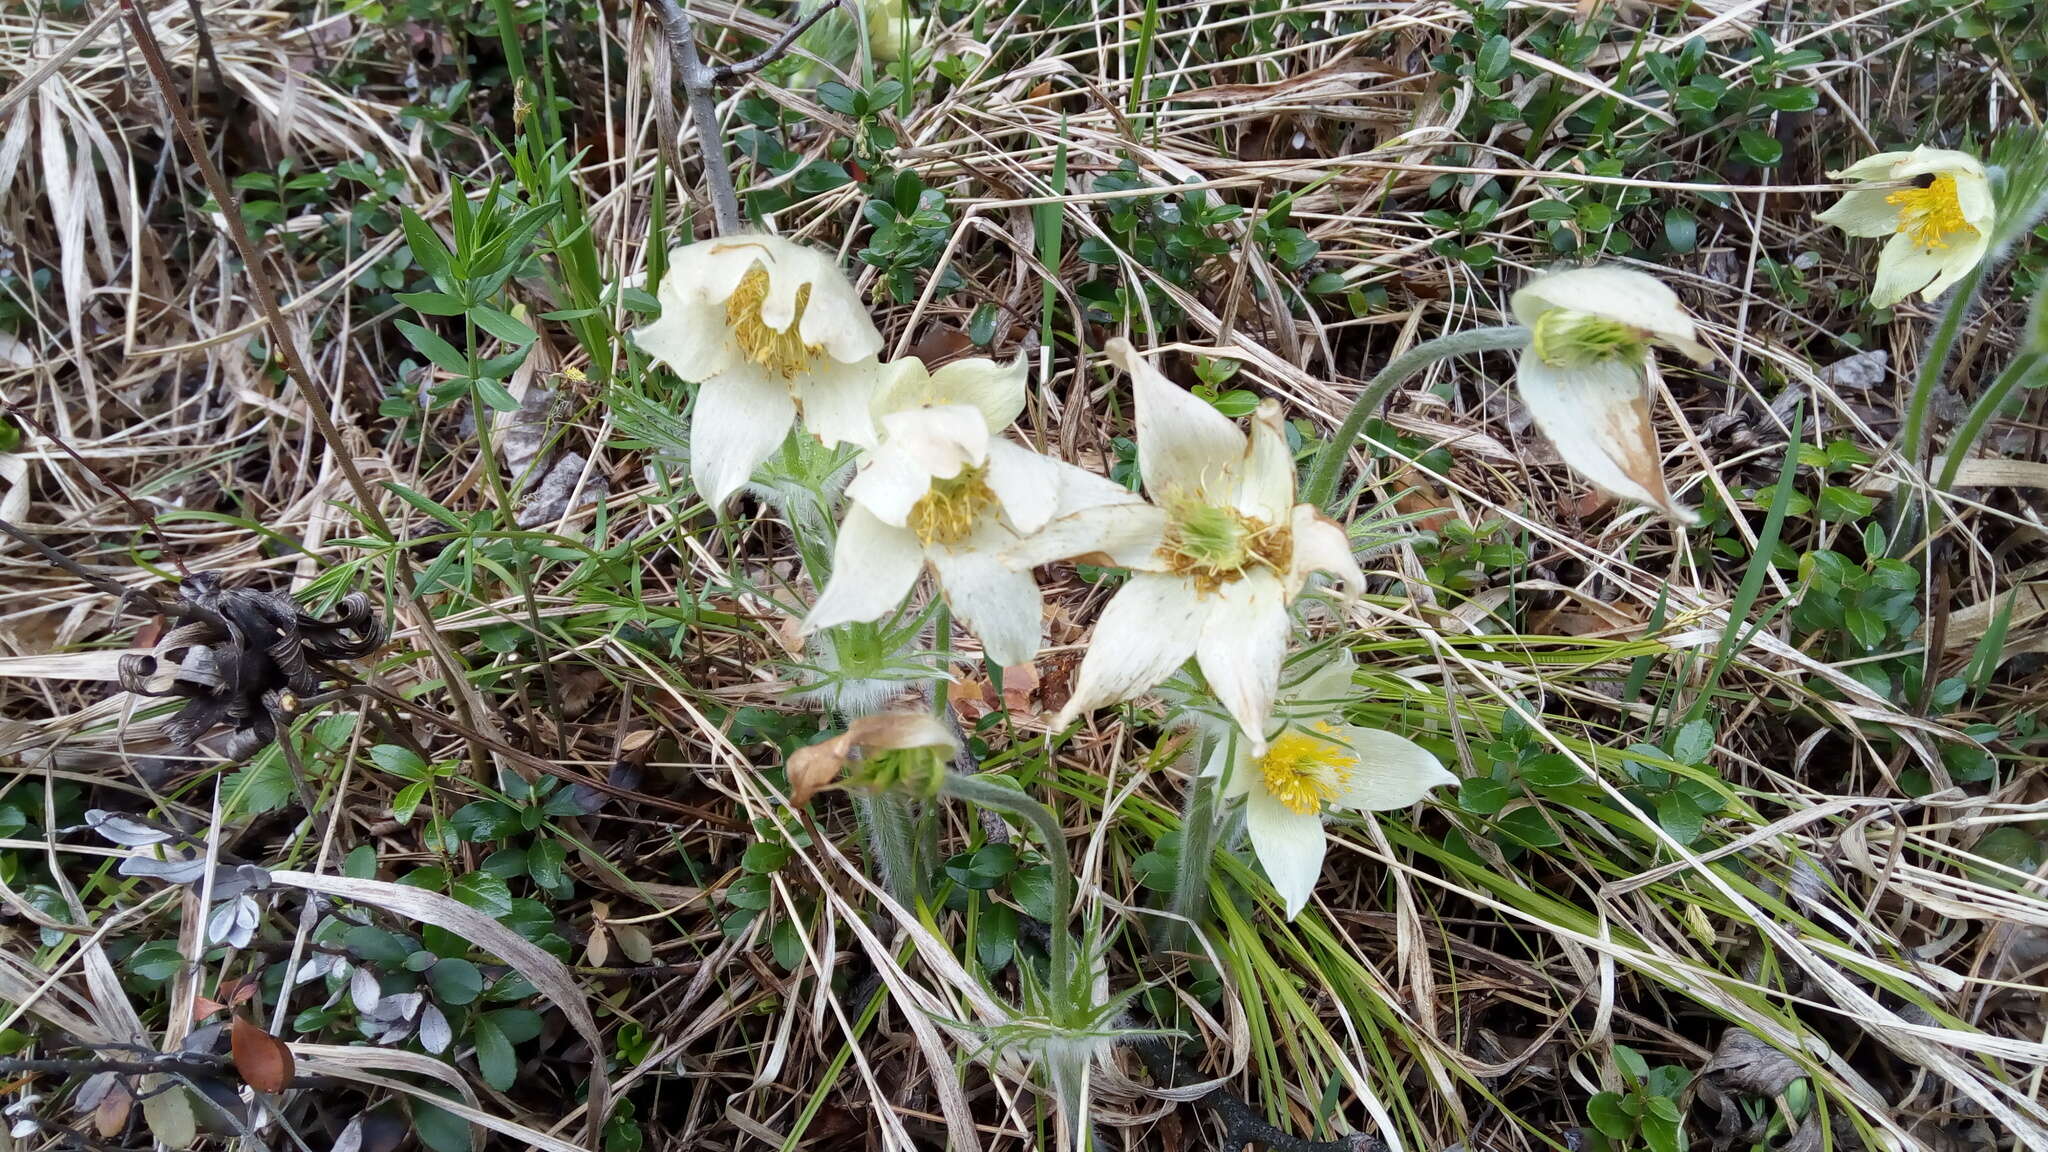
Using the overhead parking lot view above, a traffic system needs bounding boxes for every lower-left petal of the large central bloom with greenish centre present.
[1059,572,1208,726]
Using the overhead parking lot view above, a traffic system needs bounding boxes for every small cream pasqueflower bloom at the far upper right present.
[1819,148,1995,307]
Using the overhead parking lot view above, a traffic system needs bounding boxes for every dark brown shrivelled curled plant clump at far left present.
[119,572,383,756]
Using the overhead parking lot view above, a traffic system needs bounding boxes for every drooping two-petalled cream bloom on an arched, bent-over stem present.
[1511,266,1714,525]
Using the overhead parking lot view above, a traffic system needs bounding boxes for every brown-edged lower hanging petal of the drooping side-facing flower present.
[1516,348,1698,525]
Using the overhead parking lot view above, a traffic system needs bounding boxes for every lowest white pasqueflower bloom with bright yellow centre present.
[1204,650,1458,920]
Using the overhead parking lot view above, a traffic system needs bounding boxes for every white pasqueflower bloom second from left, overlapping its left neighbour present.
[803,357,1137,668]
